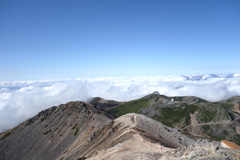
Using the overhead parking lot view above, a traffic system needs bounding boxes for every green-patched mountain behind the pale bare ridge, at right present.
[108,94,240,144]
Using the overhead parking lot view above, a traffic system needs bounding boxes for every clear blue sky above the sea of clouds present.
[0,0,240,80]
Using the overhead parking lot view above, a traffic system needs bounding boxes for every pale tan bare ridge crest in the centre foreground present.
[90,114,195,160]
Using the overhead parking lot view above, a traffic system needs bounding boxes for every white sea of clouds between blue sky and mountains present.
[0,73,240,132]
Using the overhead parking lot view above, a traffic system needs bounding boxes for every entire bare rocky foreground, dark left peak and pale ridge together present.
[0,101,240,160]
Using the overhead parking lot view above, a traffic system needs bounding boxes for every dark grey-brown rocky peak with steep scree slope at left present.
[0,101,112,160]
